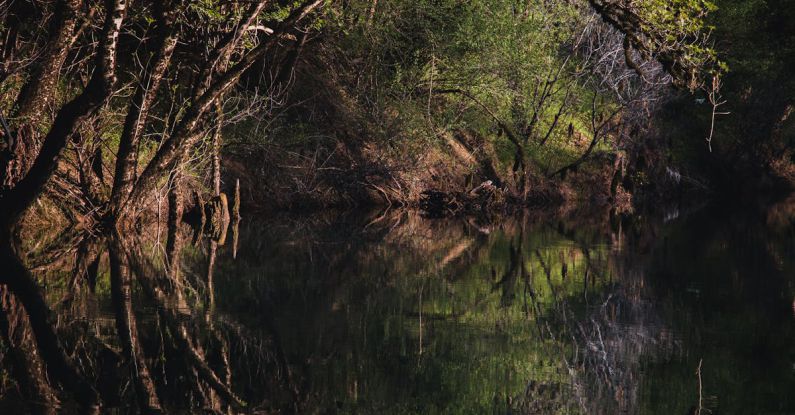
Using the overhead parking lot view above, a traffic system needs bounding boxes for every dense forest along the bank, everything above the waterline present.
[0,0,794,226]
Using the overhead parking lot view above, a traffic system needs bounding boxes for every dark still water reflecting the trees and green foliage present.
[0,205,795,415]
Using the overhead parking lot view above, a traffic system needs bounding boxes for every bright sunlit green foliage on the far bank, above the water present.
[322,0,604,173]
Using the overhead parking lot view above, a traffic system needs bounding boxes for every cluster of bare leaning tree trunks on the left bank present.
[0,0,325,231]
